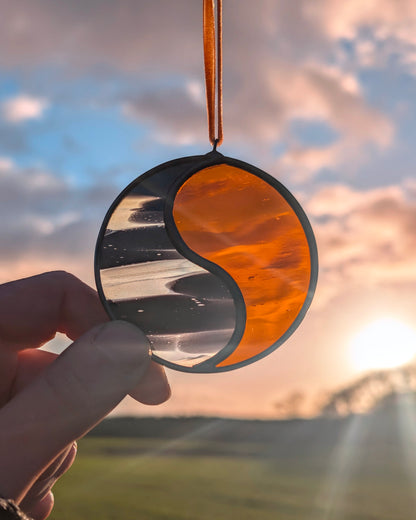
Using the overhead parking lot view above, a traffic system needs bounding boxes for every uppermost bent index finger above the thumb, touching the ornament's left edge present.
[0,271,108,350]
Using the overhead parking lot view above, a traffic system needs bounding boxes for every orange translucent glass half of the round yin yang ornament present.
[173,164,311,367]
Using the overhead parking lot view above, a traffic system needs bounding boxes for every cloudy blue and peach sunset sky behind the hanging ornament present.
[0,0,416,417]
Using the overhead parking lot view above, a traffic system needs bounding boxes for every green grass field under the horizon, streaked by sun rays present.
[52,410,416,520]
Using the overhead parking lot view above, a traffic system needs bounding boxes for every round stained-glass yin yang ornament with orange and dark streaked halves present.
[95,151,318,372]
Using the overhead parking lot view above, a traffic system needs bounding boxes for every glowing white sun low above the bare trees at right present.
[350,318,416,370]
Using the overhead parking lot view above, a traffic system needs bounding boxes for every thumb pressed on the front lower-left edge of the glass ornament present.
[0,321,169,501]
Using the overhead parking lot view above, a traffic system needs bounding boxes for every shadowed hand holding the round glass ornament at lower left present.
[0,272,170,520]
